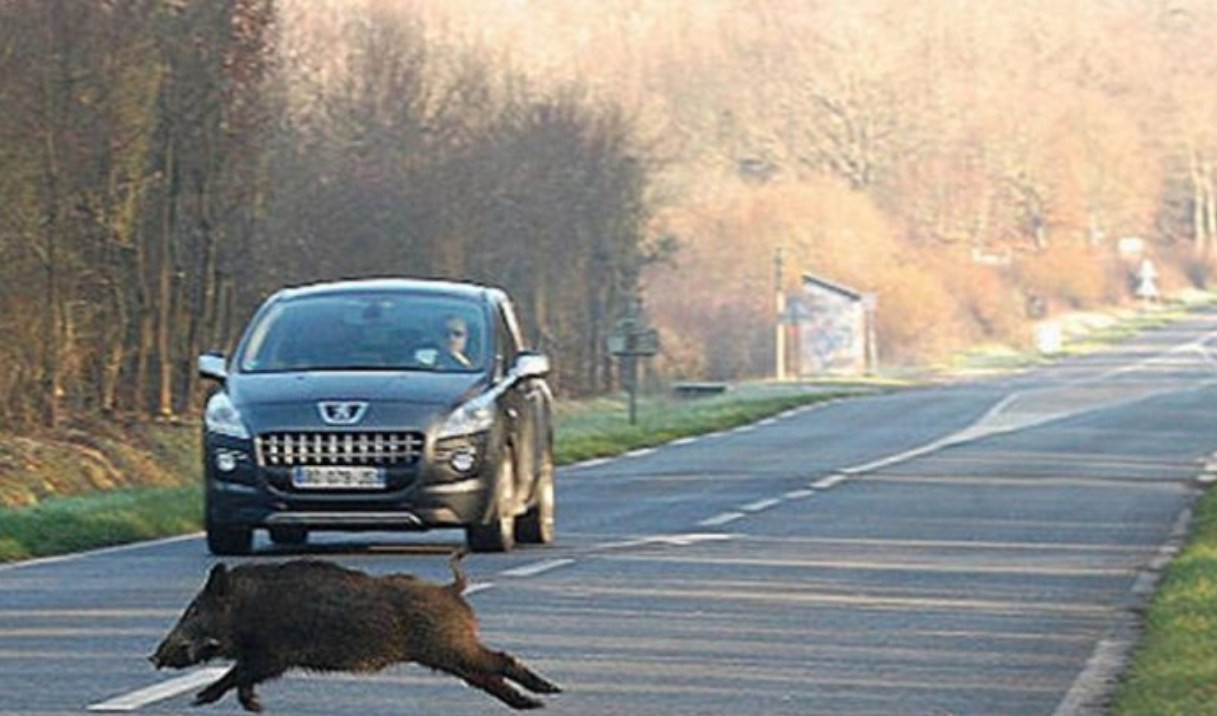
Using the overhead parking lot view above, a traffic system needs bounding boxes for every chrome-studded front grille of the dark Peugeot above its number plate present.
[257,432,424,468]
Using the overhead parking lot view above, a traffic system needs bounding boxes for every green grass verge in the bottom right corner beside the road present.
[1111,490,1217,716]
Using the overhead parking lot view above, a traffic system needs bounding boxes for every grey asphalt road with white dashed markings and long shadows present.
[7,310,1217,716]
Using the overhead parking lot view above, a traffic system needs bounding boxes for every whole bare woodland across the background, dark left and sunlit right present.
[0,0,1217,431]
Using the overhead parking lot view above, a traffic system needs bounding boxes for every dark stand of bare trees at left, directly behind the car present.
[0,0,652,430]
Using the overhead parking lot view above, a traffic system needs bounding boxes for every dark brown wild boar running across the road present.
[148,554,561,711]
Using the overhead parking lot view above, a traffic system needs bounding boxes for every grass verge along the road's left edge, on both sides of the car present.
[0,384,877,561]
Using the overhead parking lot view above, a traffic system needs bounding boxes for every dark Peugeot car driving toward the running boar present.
[198,279,555,555]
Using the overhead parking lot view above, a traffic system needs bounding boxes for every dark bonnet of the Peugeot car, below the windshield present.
[226,371,487,432]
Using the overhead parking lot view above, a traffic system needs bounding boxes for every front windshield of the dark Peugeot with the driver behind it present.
[240,292,487,373]
